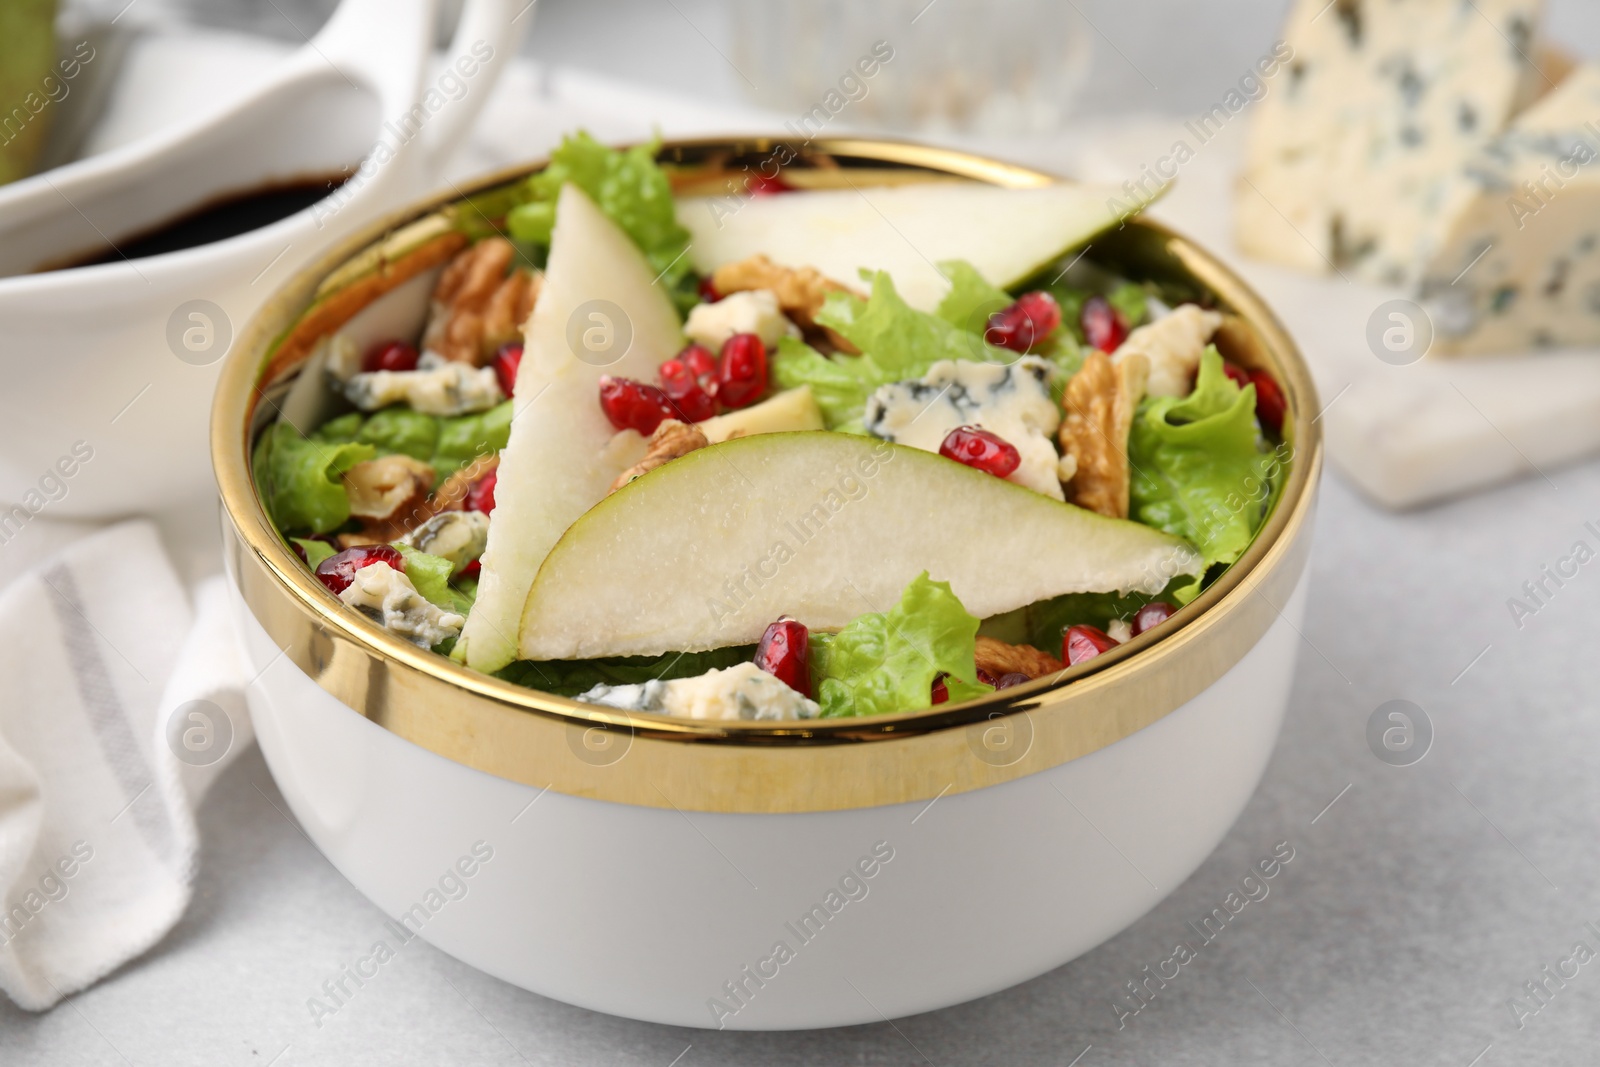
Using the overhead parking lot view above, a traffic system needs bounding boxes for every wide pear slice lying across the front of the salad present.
[518,430,1202,659]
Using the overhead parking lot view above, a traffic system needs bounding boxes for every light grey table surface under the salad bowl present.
[9,0,1600,1067]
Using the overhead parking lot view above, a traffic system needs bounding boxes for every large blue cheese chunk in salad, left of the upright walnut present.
[864,355,1066,501]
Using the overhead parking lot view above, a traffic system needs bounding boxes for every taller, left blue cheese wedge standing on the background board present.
[1235,0,1542,285]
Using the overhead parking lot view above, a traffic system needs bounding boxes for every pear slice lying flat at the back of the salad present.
[678,181,1165,312]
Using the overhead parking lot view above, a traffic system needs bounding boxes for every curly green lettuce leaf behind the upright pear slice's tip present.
[506,130,698,309]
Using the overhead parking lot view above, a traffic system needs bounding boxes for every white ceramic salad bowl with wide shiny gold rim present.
[213,141,1320,1029]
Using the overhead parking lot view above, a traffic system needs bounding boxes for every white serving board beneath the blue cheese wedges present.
[1075,110,1600,509]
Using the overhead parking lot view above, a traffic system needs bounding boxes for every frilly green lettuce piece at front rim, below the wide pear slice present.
[811,571,990,718]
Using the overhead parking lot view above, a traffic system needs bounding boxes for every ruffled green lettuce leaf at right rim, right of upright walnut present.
[1128,346,1275,588]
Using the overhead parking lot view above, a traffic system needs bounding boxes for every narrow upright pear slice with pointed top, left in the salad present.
[458,186,683,670]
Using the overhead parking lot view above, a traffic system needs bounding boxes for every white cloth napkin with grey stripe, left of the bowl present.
[0,522,253,1011]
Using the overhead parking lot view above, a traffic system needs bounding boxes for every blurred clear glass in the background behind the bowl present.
[733,0,1093,136]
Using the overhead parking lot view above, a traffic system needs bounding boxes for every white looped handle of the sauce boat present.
[310,0,534,192]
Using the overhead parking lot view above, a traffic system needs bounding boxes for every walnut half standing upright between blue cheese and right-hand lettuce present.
[1059,349,1150,518]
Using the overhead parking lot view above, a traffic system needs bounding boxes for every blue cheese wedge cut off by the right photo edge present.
[1421,66,1600,354]
